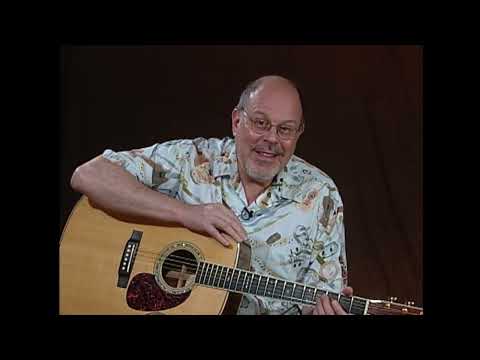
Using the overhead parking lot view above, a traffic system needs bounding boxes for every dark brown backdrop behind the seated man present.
[59,45,423,304]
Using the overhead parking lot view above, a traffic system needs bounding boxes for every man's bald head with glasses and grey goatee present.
[232,76,304,185]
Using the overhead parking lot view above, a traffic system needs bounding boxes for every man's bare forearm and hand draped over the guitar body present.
[70,156,246,246]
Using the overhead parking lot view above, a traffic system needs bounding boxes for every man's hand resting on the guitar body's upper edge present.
[181,204,247,247]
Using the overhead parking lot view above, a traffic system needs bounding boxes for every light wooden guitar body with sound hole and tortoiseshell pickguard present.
[60,196,250,315]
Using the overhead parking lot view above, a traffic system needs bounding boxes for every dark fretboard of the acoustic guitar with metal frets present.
[195,262,368,315]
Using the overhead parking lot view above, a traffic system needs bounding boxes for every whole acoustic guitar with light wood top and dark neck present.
[59,196,423,315]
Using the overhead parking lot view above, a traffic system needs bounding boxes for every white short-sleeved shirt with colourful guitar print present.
[103,138,347,314]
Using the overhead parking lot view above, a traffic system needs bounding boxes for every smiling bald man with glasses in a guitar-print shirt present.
[71,76,353,315]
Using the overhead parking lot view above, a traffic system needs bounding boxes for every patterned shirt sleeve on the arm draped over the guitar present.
[102,140,191,197]
